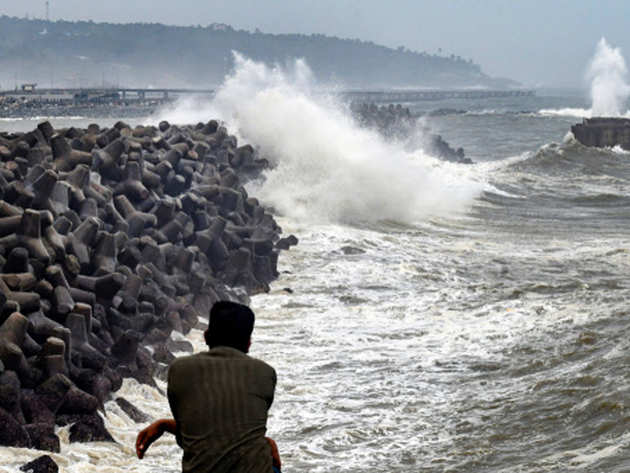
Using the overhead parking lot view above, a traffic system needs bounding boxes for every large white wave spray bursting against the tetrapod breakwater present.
[160,54,482,223]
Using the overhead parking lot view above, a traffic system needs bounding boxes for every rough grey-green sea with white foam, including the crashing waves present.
[0,58,630,473]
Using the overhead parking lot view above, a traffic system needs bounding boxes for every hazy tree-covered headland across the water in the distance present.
[0,16,519,90]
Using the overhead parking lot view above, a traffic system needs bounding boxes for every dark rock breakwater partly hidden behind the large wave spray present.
[351,103,472,164]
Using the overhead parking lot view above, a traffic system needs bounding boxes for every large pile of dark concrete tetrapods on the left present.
[0,120,297,452]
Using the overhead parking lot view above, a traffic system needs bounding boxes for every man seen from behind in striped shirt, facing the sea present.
[136,301,280,473]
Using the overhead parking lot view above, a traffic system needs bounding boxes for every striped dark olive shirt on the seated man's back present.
[168,346,276,473]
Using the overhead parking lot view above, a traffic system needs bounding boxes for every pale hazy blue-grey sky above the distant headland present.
[0,0,630,86]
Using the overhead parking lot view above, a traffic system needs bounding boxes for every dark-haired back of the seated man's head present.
[204,301,254,353]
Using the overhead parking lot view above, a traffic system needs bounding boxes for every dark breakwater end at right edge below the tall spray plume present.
[571,117,630,151]
